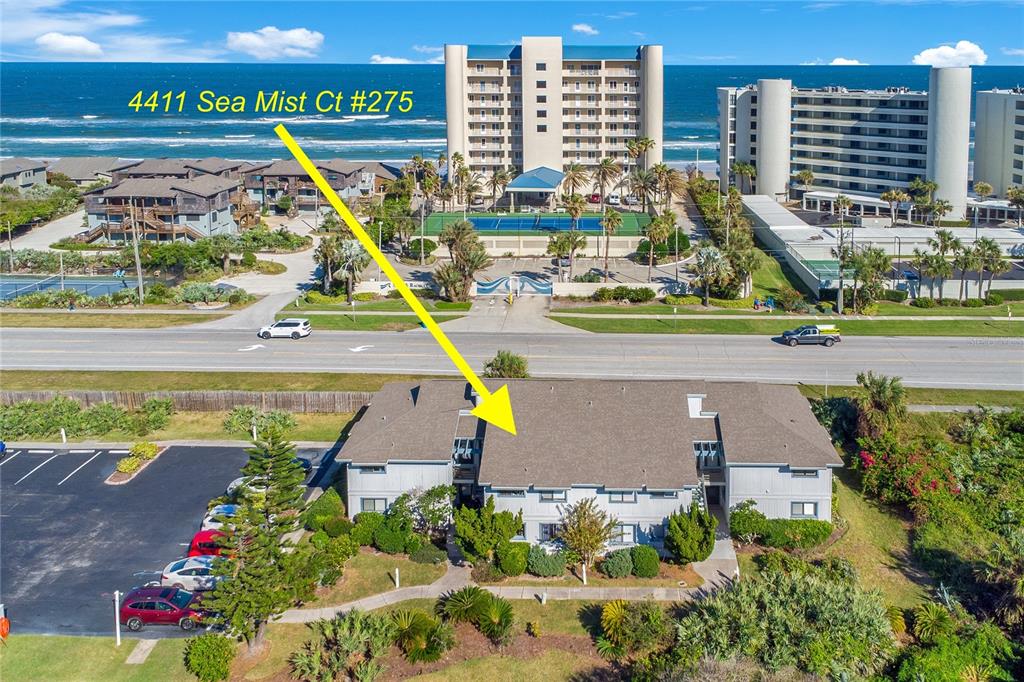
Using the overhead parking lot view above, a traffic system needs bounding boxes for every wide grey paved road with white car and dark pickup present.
[0,329,1024,390]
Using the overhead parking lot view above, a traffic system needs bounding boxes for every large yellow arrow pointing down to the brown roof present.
[273,125,516,435]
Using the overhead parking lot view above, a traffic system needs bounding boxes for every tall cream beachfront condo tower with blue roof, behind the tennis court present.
[444,37,664,180]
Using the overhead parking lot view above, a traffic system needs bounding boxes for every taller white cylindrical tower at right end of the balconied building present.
[927,67,971,220]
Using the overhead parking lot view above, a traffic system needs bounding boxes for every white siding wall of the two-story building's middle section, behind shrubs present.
[484,487,692,543]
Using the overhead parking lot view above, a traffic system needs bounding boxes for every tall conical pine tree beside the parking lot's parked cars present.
[203,429,305,653]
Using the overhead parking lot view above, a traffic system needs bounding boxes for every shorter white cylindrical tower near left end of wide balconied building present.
[751,79,793,202]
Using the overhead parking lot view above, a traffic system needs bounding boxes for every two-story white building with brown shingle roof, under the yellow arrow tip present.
[338,380,842,547]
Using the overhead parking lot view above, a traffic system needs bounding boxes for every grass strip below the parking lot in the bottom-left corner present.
[0,635,196,682]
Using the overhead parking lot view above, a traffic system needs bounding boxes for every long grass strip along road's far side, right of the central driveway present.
[551,315,1024,337]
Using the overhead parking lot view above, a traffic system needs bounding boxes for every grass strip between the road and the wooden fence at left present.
[0,370,424,391]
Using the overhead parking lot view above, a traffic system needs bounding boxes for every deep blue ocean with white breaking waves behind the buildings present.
[0,62,1024,163]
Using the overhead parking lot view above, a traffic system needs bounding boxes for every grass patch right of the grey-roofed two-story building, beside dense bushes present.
[824,472,931,608]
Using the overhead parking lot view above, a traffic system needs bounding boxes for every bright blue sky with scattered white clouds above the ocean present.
[0,0,1024,66]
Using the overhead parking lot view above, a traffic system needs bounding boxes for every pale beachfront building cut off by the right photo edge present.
[974,87,1024,199]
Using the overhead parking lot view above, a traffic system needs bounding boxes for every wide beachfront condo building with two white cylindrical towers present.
[718,67,971,220]
